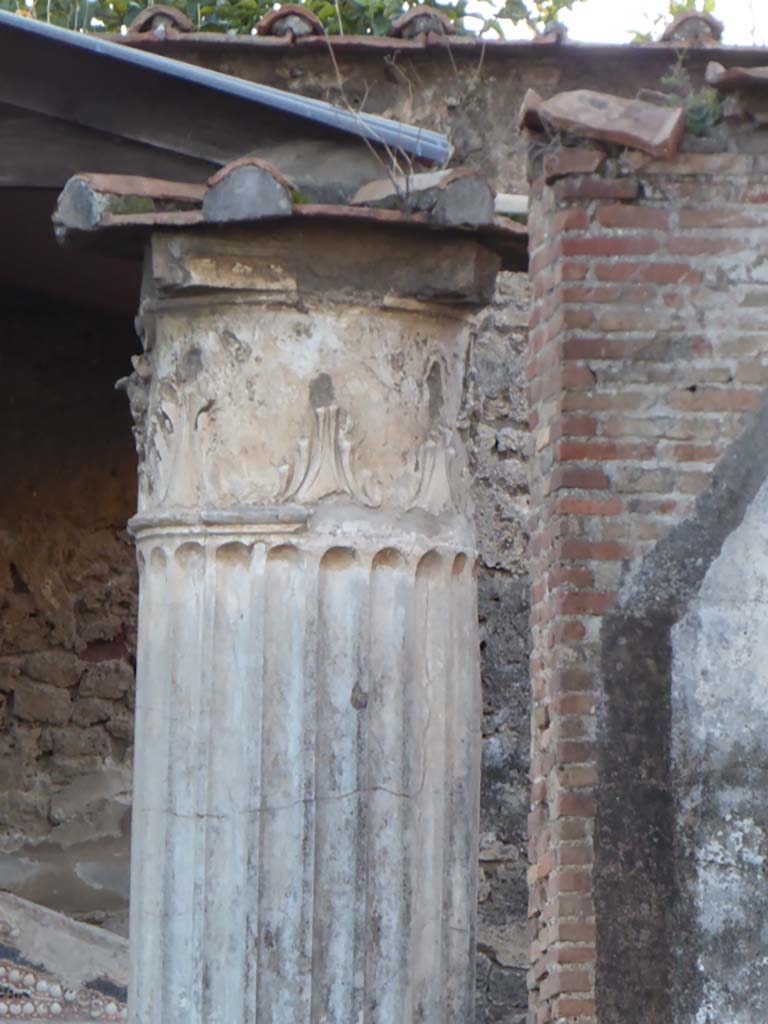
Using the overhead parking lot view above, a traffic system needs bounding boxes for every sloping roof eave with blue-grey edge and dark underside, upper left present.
[0,11,451,164]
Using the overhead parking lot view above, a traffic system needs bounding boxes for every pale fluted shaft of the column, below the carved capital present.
[131,532,479,1024]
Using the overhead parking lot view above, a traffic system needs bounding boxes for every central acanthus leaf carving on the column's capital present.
[276,406,381,508]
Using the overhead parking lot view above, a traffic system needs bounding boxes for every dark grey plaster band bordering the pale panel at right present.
[594,393,768,1024]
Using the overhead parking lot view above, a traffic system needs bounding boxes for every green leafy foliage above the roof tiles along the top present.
[0,0,577,36]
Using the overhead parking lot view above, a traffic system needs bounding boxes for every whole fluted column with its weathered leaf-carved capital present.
[129,228,493,1024]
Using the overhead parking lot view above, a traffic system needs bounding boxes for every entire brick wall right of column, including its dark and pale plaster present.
[528,146,768,1024]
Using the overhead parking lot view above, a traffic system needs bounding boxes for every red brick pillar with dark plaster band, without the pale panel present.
[527,147,768,1024]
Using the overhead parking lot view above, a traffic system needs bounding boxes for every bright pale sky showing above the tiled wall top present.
[468,0,768,46]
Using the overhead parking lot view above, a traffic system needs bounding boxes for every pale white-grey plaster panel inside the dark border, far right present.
[672,484,768,1024]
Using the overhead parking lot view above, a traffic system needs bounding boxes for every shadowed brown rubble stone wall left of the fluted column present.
[0,293,137,929]
